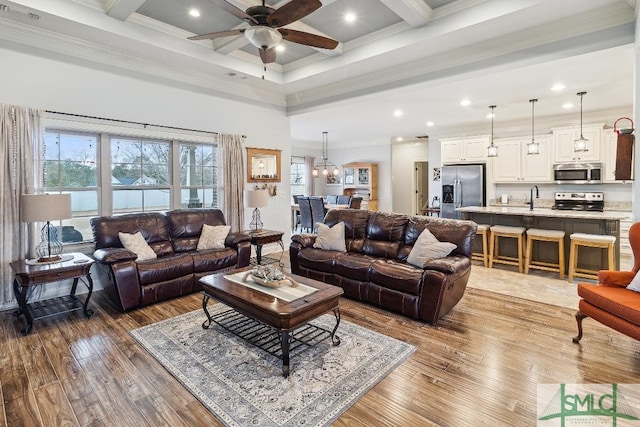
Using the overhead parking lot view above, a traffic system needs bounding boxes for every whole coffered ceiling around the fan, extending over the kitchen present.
[0,0,636,145]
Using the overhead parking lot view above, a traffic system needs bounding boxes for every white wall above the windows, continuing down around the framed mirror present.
[0,49,291,239]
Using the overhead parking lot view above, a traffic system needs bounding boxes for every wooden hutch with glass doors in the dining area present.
[342,162,378,211]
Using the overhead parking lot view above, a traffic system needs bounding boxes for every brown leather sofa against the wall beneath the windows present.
[91,209,251,311]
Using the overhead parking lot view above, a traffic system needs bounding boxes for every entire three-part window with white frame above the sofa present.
[44,122,221,244]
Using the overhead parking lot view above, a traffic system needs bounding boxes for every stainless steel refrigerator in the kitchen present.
[440,164,486,219]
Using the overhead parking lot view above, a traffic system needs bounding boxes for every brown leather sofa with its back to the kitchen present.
[289,209,477,324]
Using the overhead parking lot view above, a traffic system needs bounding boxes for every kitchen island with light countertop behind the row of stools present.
[456,206,631,270]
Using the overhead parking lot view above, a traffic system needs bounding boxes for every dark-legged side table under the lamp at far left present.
[11,252,94,335]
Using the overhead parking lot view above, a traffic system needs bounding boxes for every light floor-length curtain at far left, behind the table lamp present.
[0,104,44,306]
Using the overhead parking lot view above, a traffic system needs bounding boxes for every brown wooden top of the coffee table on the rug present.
[200,267,344,329]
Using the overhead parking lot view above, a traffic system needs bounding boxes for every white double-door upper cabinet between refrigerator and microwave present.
[491,135,552,183]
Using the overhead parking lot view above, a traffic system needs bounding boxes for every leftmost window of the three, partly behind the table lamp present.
[44,131,99,243]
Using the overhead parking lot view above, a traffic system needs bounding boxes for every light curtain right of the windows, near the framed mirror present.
[219,134,244,231]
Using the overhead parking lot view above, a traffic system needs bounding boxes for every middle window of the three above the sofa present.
[111,138,171,214]
